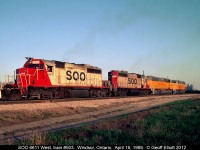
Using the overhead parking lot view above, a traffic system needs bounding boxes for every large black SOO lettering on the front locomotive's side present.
[66,70,85,81]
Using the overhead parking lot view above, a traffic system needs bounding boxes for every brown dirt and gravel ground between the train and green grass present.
[0,94,200,144]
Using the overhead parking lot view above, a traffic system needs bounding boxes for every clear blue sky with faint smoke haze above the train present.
[0,0,200,89]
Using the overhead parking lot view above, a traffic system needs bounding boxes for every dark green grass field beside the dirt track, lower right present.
[17,99,200,145]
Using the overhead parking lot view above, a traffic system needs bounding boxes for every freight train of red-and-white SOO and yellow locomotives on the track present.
[0,57,186,100]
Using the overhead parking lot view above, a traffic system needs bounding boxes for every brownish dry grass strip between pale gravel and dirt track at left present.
[0,107,97,127]
